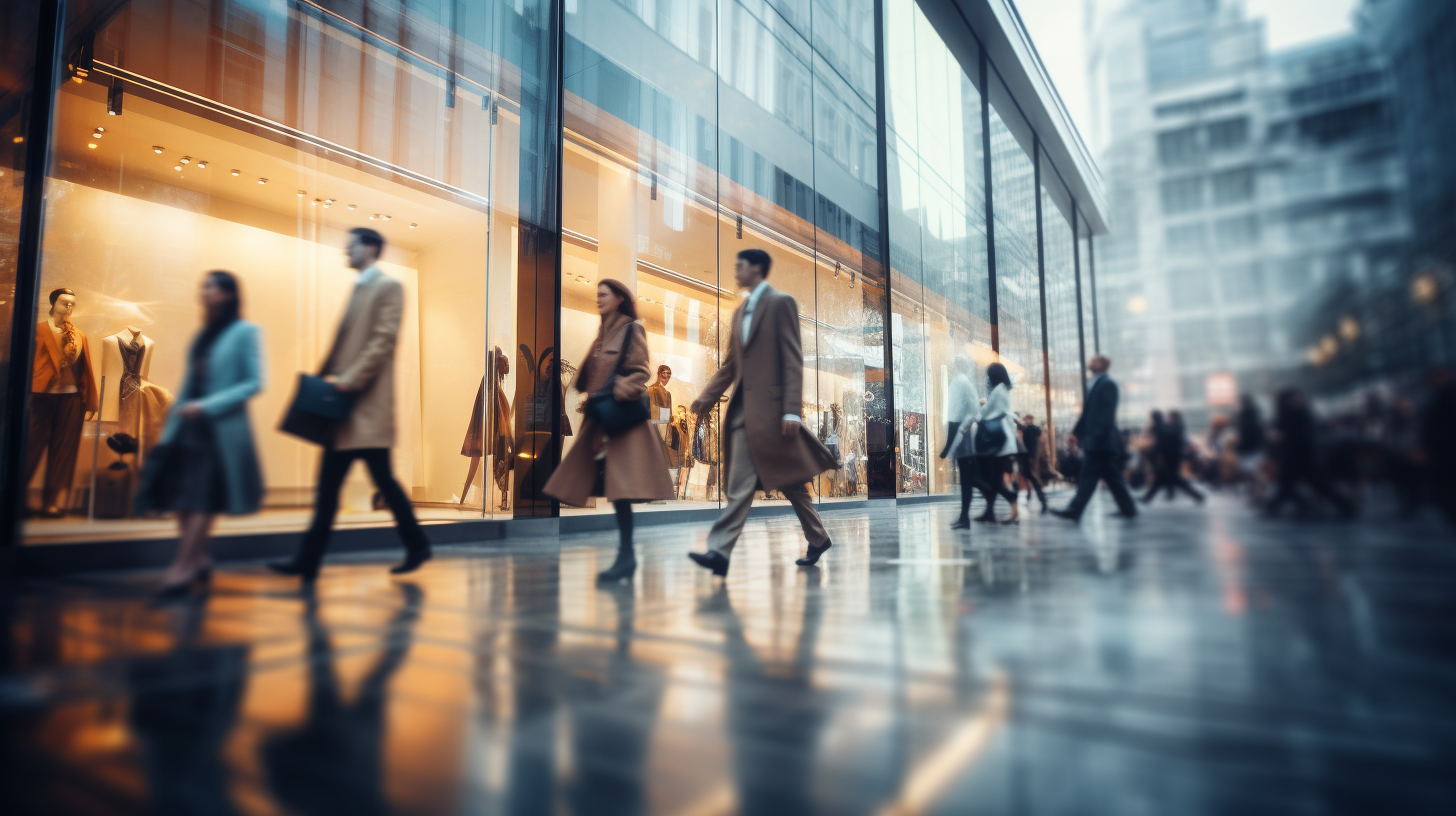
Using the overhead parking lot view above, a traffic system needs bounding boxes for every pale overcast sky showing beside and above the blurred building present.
[1015,0,1356,138]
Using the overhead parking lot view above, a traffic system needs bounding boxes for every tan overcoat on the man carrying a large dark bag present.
[322,267,405,450]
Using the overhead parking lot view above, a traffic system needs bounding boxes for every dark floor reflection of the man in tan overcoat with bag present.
[261,583,425,816]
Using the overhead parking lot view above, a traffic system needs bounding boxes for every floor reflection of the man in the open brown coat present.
[699,581,828,813]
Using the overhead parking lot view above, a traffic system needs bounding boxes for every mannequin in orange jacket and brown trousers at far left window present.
[25,289,100,519]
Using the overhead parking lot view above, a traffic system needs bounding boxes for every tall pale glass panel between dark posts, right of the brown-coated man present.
[885,0,992,494]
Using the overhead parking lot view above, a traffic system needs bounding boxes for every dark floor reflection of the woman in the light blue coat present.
[127,603,248,816]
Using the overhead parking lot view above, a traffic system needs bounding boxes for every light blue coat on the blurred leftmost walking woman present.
[138,321,264,516]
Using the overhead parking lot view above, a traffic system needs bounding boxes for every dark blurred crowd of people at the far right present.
[1100,367,1456,525]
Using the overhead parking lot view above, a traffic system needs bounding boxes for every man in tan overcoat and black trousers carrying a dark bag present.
[268,227,431,581]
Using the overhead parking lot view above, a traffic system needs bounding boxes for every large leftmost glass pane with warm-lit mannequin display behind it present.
[26,0,535,539]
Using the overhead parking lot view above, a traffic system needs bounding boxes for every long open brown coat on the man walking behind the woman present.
[697,287,837,490]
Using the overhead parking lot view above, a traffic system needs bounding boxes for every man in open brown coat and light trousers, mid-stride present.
[689,249,836,576]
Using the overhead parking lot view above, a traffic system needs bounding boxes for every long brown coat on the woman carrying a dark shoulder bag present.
[545,315,676,507]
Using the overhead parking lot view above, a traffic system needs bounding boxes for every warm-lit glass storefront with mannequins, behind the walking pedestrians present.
[0,0,1089,542]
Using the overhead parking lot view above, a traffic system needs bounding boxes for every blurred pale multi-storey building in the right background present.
[1089,0,1408,423]
